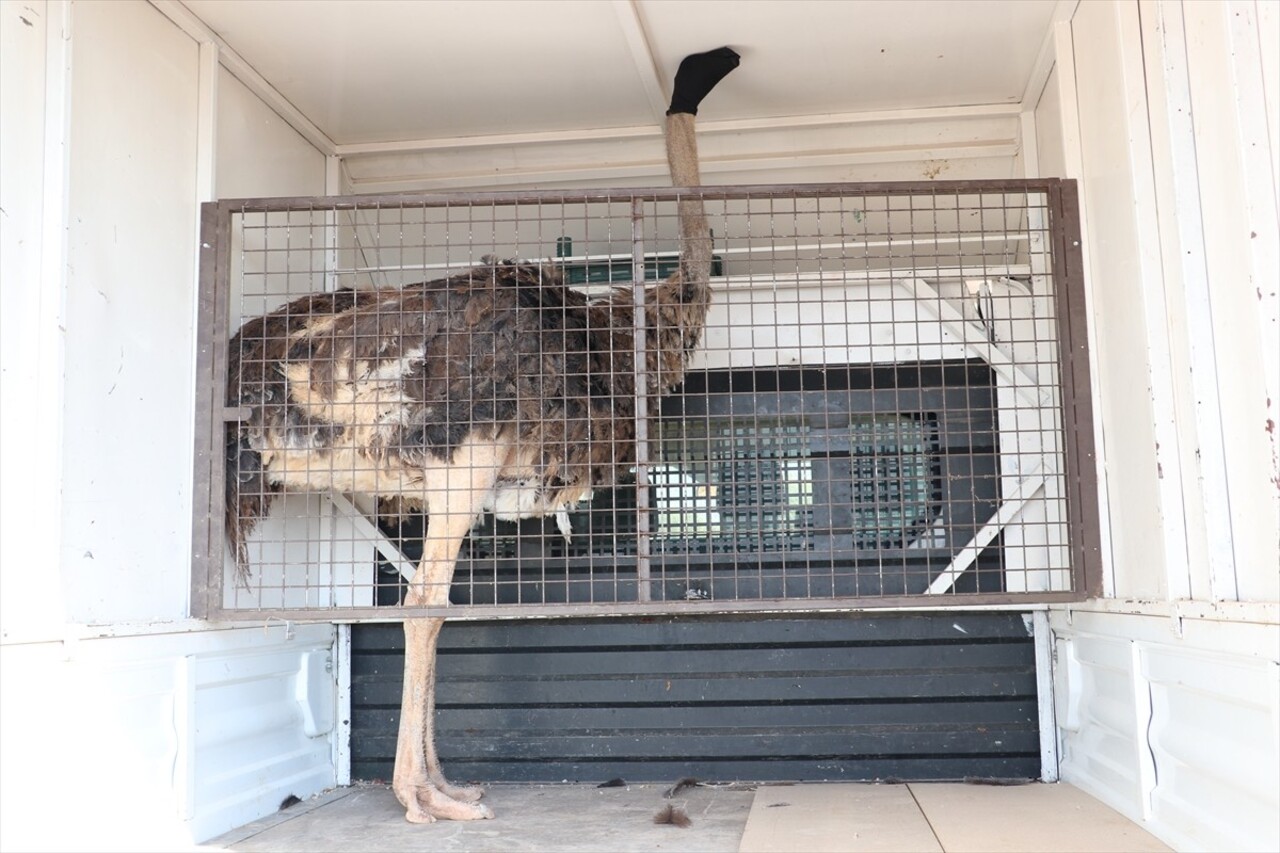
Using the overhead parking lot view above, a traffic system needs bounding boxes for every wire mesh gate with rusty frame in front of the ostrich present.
[193,181,1097,619]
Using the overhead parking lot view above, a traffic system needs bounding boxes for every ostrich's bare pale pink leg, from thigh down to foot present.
[392,442,499,824]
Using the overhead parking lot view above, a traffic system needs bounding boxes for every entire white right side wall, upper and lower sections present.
[1037,0,1280,850]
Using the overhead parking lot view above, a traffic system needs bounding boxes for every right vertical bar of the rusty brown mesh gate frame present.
[1048,181,1102,598]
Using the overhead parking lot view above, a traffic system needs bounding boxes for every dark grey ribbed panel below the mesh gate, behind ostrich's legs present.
[351,613,1041,781]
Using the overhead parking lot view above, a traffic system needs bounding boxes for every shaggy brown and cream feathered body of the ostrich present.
[227,252,709,570]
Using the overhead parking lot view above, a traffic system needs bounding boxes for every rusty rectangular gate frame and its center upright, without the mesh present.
[189,178,1103,624]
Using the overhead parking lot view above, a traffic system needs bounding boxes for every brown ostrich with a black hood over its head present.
[227,47,739,822]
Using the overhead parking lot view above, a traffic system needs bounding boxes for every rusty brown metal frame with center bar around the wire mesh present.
[192,178,1101,621]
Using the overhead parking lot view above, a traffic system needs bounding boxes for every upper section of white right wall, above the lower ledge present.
[1037,0,1280,601]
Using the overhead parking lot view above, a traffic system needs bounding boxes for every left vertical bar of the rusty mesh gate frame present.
[188,202,230,619]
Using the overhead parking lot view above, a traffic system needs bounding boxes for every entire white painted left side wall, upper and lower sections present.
[0,0,335,850]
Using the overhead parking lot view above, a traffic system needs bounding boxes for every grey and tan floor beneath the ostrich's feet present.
[201,784,1169,853]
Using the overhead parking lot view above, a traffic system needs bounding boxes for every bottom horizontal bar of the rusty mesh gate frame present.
[194,592,1085,622]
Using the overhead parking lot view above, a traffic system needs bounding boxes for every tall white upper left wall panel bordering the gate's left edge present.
[61,3,198,622]
